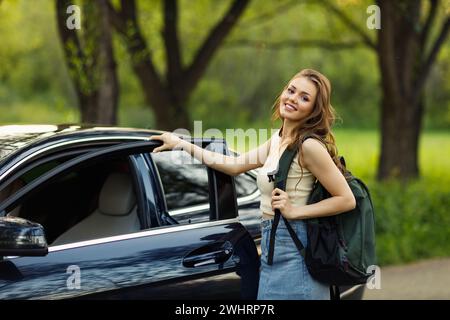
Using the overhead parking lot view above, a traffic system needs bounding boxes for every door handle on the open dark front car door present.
[183,241,233,268]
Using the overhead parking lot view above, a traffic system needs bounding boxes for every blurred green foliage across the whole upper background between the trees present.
[0,0,450,129]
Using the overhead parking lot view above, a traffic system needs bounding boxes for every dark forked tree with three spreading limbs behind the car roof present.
[108,0,249,130]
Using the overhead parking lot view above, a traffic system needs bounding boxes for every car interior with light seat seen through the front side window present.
[3,157,141,246]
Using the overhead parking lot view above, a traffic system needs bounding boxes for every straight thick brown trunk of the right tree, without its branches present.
[377,0,423,180]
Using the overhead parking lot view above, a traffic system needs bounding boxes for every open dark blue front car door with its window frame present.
[0,142,258,299]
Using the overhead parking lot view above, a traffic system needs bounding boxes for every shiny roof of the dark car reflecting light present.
[0,124,164,162]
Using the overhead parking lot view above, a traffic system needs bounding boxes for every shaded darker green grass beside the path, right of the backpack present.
[369,177,450,265]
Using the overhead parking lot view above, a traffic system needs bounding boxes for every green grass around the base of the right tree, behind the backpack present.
[232,129,450,265]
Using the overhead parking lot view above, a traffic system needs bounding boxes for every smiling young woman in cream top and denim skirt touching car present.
[151,69,356,300]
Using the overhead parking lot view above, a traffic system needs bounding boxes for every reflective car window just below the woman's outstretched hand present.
[151,150,209,223]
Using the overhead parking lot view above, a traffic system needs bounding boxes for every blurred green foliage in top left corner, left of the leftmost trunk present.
[0,0,74,109]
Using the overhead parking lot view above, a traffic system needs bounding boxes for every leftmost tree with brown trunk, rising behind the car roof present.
[55,0,119,125]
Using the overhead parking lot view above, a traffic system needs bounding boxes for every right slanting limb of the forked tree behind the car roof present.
[185,0,250,92]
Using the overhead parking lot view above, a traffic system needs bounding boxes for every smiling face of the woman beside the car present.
[280,77,317,121]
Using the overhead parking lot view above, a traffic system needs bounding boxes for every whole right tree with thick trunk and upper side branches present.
[324,0,450,180]
